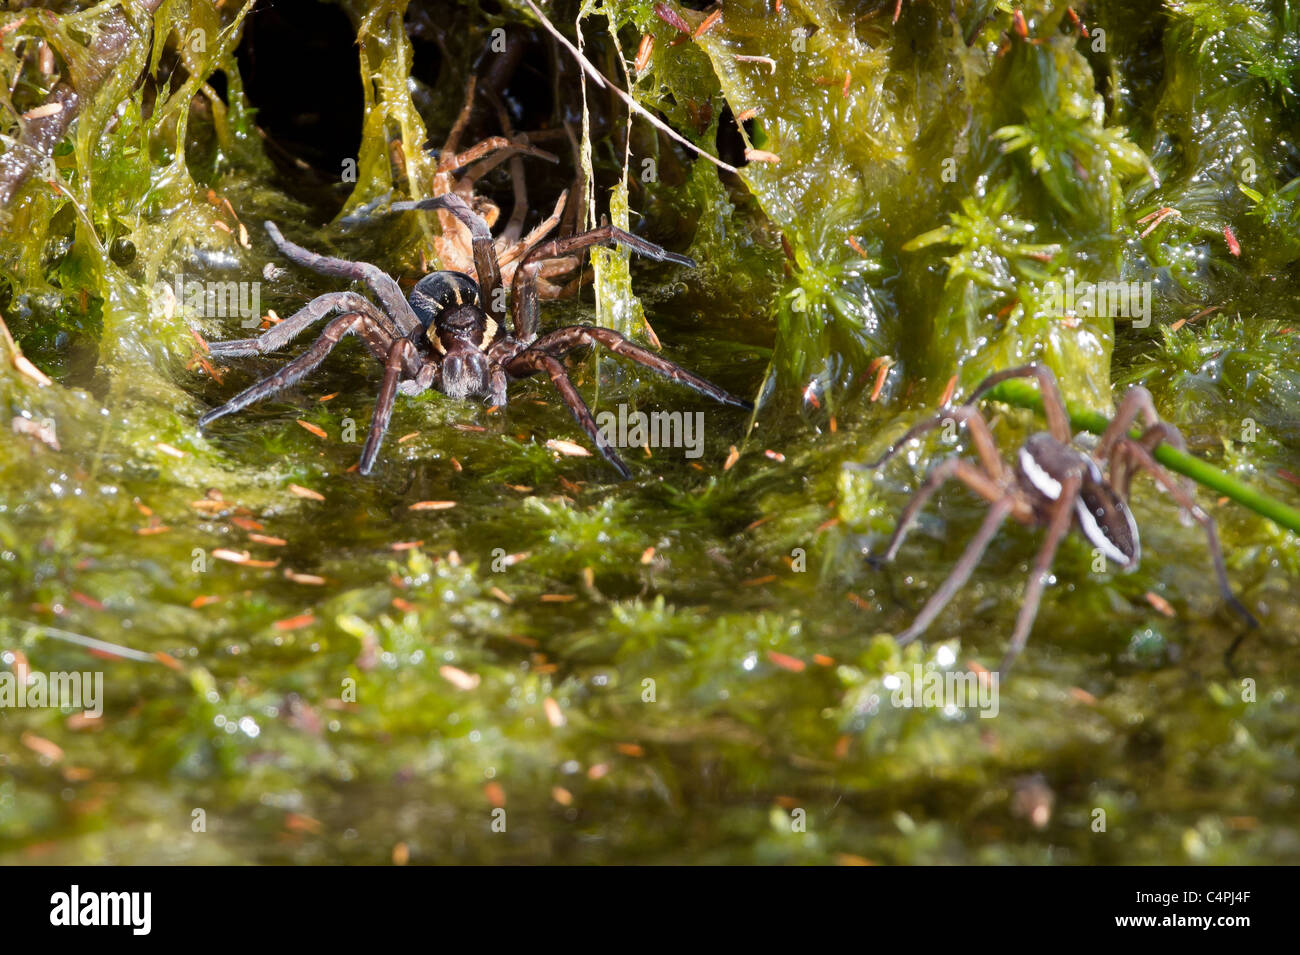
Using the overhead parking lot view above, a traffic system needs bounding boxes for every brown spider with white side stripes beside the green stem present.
[846,365,1258,672]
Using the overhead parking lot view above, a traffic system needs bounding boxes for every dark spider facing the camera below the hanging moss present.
[199,194,753,478]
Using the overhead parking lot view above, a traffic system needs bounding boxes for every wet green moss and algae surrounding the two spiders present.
[0,0,1300,864]
